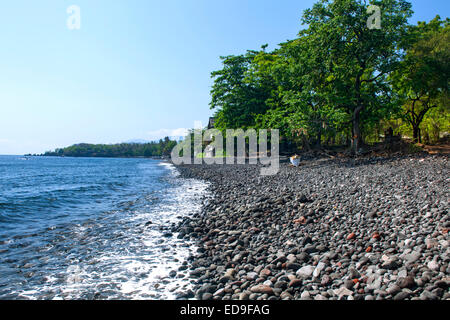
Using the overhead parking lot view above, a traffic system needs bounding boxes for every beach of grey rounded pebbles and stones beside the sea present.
[171,155,450,300]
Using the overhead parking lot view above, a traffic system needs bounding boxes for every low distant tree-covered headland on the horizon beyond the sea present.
[42,137,177,158]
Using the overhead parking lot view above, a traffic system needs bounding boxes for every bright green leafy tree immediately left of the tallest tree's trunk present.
[272,32,346,148]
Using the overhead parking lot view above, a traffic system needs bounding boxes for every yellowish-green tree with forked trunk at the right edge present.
[392,16,450,142]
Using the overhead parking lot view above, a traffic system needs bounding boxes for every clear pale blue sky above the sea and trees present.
[0,0,450,155]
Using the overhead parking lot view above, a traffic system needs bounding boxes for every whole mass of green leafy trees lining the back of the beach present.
[206,0,450,152]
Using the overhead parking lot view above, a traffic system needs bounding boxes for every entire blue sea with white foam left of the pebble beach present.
[0,156,207,299]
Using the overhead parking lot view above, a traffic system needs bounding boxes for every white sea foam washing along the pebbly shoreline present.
[21,163,207,299]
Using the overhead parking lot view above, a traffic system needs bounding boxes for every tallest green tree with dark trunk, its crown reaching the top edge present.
[302,0,412,152]
